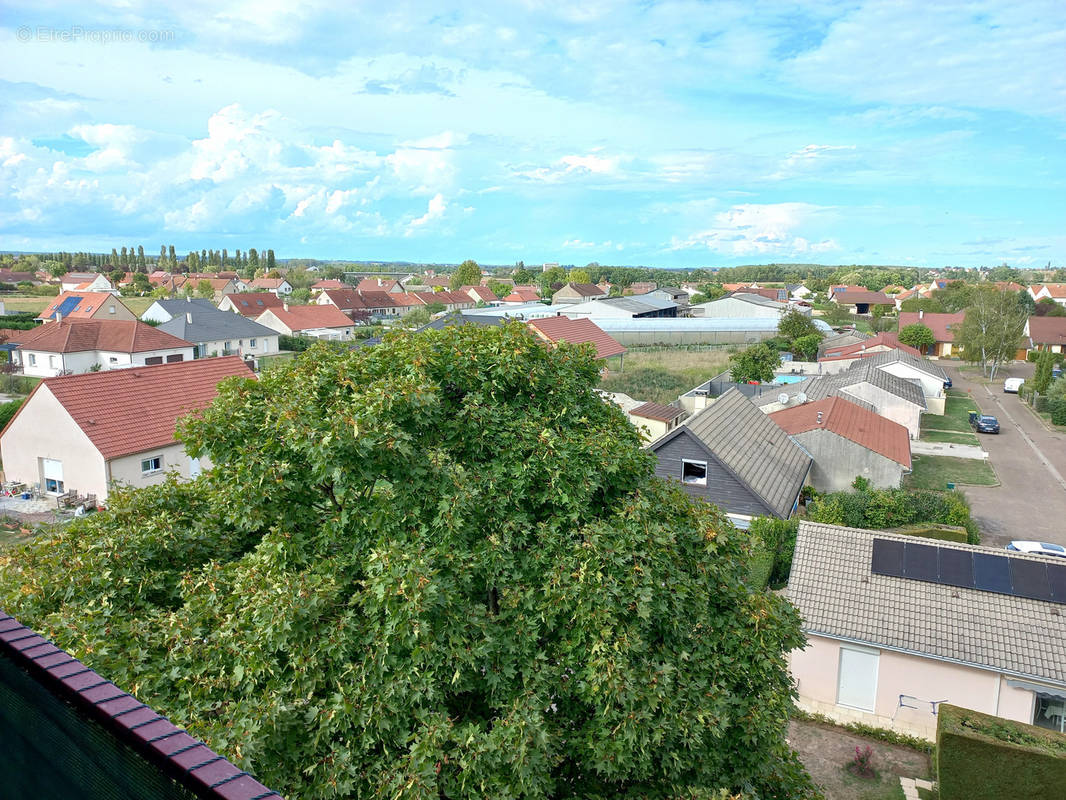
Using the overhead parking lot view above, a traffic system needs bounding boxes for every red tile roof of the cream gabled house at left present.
[30,355,254,459]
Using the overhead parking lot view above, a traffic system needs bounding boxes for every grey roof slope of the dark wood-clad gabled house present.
[677,388,811,518]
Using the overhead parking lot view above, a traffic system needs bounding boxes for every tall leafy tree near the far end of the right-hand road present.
[953,288,1028,379]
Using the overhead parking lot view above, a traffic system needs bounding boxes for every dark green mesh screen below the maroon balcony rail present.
[0,652,196,800]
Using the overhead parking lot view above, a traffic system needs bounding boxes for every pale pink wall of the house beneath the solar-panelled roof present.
[790,635,1035,740]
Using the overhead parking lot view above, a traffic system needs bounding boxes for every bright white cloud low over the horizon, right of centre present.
[671,203,839,256]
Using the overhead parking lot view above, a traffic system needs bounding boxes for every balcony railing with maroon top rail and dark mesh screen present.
[0,611,281,800]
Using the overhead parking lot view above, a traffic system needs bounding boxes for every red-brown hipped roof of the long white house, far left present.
[18,319,192,353]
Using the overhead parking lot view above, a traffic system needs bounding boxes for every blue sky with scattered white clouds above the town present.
[0,0,1066,268]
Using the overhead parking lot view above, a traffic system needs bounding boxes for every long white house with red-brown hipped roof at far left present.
[12,319,193,378]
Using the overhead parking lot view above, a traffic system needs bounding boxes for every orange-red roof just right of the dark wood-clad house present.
[770,397,910,469]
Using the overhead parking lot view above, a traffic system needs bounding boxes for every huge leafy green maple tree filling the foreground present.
[0,324,812,799]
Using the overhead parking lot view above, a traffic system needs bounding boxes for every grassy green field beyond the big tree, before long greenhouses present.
[600,350,729,405]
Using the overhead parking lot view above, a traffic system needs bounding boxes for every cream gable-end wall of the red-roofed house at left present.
[0,385,108,498]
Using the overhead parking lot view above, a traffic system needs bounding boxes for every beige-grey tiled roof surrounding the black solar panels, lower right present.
[786,522,1066,686]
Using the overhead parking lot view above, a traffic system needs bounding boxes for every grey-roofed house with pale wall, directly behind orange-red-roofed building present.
[754,358,926,438]
